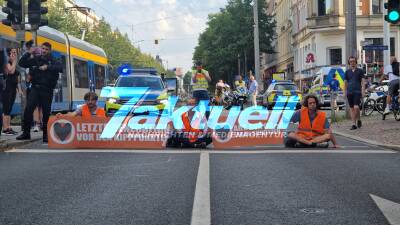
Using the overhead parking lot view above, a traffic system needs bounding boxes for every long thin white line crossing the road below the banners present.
[6,149,398,154]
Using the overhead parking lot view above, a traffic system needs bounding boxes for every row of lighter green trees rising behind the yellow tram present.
[46,0,165,79]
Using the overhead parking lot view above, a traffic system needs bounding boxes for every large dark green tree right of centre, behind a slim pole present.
[193,0,275,83]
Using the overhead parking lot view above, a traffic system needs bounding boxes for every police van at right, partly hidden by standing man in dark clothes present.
[308,67,346,107]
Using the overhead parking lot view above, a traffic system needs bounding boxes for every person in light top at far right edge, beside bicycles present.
[381,56,400,114]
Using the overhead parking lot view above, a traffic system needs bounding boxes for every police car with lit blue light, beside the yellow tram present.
[105,73,175,116]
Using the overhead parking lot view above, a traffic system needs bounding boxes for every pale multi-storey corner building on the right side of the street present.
[266,0,400,87]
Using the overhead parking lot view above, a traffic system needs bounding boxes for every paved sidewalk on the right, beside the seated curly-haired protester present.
[332,112,400,151]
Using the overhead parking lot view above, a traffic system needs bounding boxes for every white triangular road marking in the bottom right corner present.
[369,194,400,225]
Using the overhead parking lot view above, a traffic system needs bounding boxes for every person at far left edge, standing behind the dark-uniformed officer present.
[3,48,22,135]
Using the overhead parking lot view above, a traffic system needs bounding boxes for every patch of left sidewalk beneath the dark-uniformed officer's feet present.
[0,126,42,152]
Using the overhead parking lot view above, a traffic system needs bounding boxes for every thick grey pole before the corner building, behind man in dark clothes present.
[345,0,357,118]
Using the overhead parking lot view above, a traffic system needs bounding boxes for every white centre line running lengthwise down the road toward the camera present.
[191,152,211,225]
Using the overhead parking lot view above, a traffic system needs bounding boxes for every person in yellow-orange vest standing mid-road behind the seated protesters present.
[192,60,211,119]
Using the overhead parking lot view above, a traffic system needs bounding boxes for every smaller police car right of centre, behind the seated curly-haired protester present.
[262,80,303,109]
